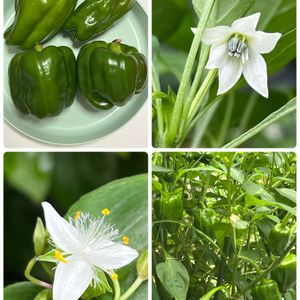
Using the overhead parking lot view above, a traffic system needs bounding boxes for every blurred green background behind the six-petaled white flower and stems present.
[152,0,296,148]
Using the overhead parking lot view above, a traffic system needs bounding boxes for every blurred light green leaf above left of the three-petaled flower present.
[4,152,53,203]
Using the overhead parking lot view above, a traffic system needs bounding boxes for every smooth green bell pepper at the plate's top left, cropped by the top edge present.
[4,0,77,49]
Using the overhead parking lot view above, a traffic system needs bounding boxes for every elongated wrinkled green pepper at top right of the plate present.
[64,0,136,42]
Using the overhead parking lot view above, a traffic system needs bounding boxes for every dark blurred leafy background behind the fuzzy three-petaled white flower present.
[4,152,148,299]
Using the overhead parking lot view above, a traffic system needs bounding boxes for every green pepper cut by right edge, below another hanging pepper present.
[271,253,297,293]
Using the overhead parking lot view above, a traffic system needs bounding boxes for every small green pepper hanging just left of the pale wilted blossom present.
[194,208,217,237]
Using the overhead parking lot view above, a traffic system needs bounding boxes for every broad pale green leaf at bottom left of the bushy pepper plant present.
[156,259,190,300]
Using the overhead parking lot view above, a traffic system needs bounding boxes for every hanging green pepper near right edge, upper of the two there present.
[268,223,292,256]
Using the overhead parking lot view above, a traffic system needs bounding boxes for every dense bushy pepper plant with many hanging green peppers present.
[152,152,296,300]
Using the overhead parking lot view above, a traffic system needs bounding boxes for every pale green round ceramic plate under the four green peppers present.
[4,0,148,145]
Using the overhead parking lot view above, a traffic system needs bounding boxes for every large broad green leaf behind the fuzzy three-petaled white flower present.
[67,174,148,300]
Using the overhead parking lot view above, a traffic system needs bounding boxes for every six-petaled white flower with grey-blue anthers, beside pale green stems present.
[192,13,281,98]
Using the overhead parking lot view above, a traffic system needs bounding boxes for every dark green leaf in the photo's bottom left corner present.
[4,281,43,300]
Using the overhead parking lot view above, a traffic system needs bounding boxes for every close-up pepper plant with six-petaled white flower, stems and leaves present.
[152,0,296,148]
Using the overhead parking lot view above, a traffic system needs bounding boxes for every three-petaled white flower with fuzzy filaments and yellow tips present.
[42,202,138,300]
